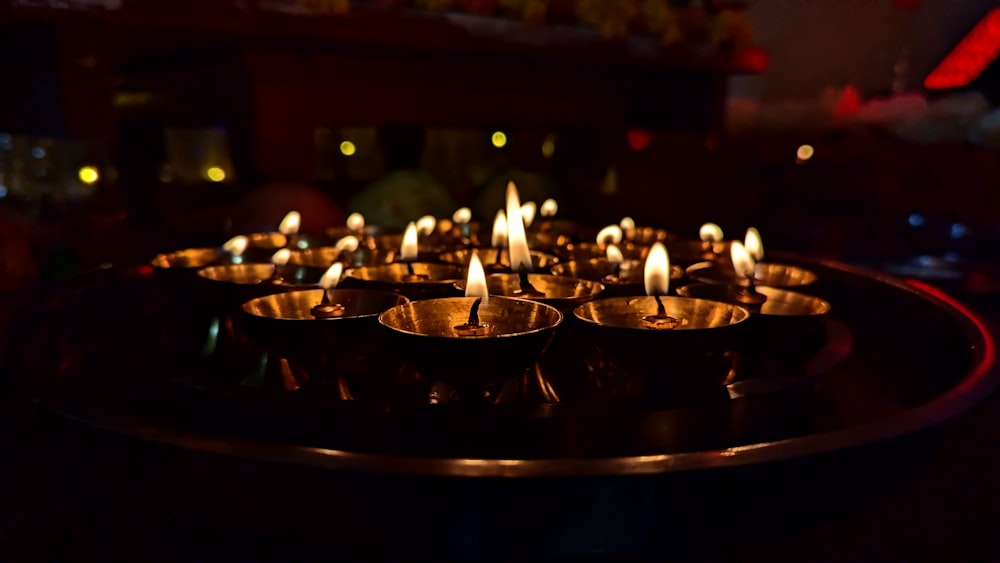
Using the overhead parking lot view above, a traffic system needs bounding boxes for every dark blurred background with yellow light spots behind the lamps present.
[0,0,1000,294]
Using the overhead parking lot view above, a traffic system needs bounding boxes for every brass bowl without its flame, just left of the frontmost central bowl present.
[240,289,408,371]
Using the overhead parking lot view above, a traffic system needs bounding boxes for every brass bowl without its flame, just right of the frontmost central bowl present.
[573,297,750,406]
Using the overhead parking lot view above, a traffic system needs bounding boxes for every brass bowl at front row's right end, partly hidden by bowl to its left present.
[677,283,831,363]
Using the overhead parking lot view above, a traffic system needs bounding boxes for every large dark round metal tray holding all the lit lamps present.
[11,256,997,478]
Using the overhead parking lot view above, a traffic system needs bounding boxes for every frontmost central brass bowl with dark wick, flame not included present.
[379,297,563,399]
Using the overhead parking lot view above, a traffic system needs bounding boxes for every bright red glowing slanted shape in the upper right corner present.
[924,8,1000,90]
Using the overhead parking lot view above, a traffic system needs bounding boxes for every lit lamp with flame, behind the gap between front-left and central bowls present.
[344,222,466,299]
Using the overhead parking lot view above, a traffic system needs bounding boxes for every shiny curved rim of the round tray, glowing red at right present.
[25,252,1000,478]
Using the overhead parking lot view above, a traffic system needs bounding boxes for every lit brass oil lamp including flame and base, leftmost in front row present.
[237,263,407,400]
